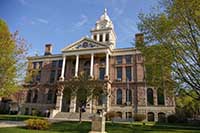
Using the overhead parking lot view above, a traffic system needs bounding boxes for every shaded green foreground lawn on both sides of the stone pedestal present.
[0,122,200,133]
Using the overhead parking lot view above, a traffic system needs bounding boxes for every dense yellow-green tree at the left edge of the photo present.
[0,19,28,97]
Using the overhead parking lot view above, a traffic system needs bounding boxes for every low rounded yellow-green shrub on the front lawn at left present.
[25,119,50,130]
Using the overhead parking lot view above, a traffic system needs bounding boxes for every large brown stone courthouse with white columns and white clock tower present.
[22,10,175,121]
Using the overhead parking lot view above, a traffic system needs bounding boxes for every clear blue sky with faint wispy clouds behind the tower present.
[0,0,157,55]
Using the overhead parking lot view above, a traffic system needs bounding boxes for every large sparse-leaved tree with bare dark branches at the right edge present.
[138,0,200,99]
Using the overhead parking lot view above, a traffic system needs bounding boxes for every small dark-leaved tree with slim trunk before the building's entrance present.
[62,73,104,123]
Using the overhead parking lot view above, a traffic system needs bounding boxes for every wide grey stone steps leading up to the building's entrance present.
[54,112,92,121]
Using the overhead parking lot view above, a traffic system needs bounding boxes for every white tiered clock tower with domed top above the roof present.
[91,9,116,48]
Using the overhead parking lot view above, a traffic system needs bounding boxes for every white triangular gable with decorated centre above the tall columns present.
[61,37,109,52]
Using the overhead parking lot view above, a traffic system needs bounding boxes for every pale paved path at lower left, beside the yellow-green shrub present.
[0,121,25,128]
